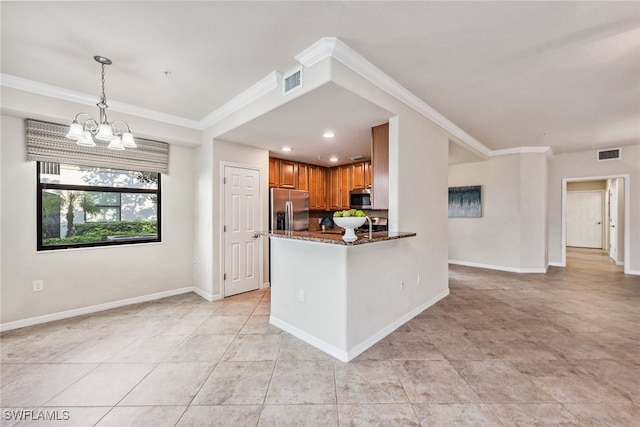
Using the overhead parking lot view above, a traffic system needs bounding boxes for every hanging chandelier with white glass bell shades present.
[67,55,136,150]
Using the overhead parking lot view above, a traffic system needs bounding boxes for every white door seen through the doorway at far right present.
[567,191,603,249]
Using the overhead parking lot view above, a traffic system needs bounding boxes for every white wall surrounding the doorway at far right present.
[548,145,640,274]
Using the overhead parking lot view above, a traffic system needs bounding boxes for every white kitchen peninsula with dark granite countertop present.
[265,231,430,362]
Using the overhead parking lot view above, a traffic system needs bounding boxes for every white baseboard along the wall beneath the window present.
[0,286,199,332]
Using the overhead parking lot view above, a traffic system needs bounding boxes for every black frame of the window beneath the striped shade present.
[36,161,162,252]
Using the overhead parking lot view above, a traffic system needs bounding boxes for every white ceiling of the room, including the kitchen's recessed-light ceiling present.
[0,1,640,163]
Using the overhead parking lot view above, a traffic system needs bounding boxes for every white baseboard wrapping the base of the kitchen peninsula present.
[269,288,449,362]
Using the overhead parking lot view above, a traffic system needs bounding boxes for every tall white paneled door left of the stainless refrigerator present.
[223,166,261,297]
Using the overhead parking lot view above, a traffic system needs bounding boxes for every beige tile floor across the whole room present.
[1,250,640,427]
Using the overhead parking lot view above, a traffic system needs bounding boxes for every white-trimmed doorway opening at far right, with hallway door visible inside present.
[562,175,630,273]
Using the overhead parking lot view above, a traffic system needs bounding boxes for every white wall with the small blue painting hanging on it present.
[448,153,547,272]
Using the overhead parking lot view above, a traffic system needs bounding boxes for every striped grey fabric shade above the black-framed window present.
[26,119,169,174]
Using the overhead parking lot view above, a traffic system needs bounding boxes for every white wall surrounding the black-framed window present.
[0,115,194,324]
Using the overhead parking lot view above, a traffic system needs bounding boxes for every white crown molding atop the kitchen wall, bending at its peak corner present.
[295,37,491,156]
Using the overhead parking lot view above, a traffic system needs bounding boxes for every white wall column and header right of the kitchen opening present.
[331,58,451,307]
